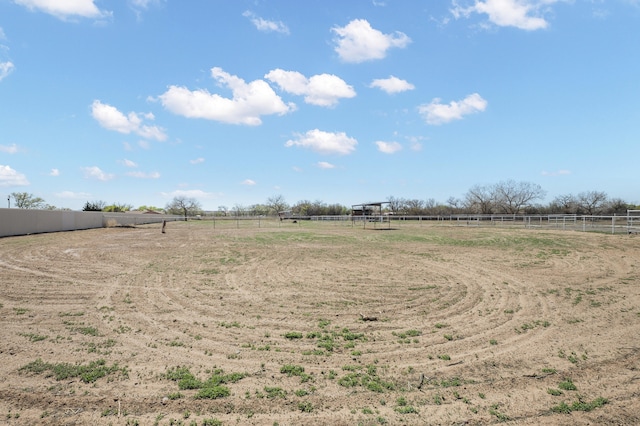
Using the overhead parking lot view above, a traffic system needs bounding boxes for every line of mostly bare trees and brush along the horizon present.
[9,180,640,218]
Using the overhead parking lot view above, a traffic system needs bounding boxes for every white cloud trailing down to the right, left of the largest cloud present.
[91,100,167,141]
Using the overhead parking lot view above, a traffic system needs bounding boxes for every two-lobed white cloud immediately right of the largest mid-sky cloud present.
[264,69,356,107]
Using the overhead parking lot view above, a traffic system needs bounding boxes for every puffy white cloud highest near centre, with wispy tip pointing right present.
[332,19,411,63]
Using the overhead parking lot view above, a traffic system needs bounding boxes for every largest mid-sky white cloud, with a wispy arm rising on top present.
[159,67,295,126]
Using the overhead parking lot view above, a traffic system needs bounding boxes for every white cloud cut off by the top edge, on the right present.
[451,0,562,31]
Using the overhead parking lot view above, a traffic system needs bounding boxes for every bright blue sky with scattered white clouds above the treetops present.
[0,0,640,210]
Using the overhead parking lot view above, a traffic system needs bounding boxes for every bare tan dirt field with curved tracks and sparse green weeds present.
[0,222,640,425]
